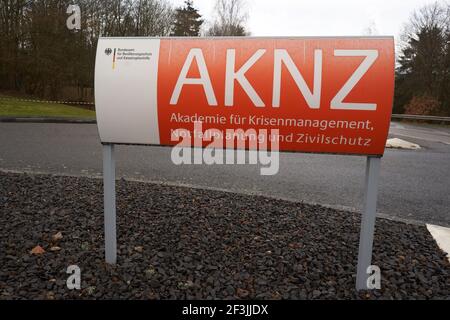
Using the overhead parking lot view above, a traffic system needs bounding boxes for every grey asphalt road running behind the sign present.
[0,123,450,226]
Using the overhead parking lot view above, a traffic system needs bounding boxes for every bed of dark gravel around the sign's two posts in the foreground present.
[0,173,450,299]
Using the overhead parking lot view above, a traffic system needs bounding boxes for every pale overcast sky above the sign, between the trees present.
[169,0,442,37]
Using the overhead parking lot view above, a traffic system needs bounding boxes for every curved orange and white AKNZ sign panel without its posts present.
[96,37,395,155]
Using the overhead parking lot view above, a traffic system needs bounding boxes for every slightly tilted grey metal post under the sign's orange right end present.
[356,156,381,290]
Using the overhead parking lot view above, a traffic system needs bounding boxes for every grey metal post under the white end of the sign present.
[103,144,117,264]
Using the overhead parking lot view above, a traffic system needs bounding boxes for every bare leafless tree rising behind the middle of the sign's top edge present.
[206,0,249,36]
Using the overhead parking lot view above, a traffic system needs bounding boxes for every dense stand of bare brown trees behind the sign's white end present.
[0,0,174,100]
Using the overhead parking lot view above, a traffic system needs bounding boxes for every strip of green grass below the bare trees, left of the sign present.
[0,95,95,119]
